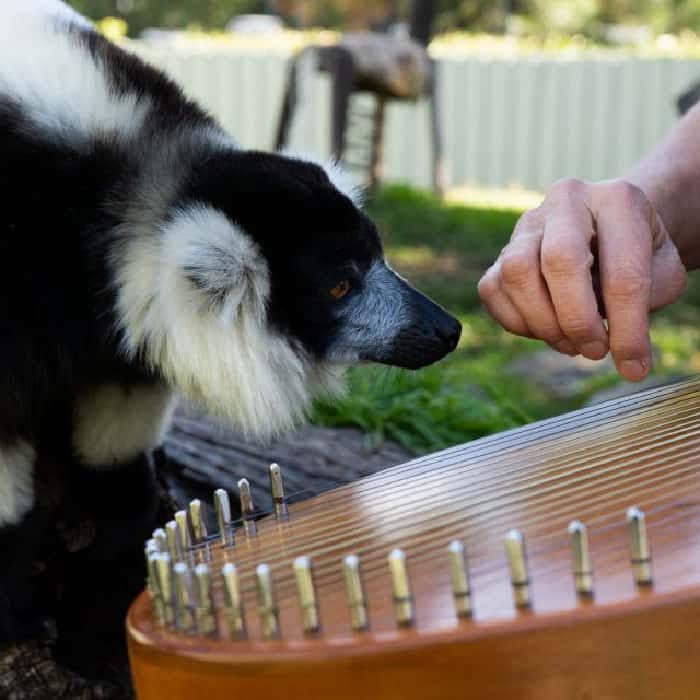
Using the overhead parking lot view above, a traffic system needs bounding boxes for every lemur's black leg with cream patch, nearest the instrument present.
[57,384,175,675]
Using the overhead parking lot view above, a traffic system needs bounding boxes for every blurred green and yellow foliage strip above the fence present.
[69,0,700,39]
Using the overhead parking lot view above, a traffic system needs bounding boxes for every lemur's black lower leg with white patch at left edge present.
[0,438,43,642]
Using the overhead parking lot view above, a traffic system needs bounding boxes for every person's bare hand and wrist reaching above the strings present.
[479,101,700,381]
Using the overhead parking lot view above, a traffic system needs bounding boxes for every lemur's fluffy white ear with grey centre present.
[168,207,270,320]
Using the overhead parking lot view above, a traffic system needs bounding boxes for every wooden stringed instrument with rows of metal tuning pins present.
[127,380,700,700]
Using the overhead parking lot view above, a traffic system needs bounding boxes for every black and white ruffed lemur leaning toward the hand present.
[0,0,460,676]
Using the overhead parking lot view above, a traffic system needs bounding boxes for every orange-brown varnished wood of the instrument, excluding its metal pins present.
[128,381,700,700]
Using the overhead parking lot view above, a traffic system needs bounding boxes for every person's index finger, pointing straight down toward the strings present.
[597,183,653,381]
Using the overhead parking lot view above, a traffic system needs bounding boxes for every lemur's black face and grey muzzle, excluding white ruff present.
[196,153,461,369]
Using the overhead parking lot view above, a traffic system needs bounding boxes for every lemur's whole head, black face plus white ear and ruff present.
[120,151,461,436]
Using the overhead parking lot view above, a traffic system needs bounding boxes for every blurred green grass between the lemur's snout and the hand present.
[312,186,700,454]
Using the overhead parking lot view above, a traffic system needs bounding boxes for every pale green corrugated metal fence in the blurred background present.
[131,42,700,189]
